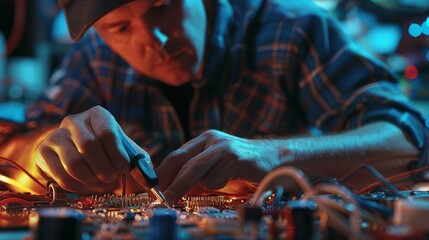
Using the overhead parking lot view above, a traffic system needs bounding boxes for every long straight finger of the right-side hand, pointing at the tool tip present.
[160,147,222,202]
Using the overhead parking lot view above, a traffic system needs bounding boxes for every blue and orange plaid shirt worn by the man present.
[26,0,427,165]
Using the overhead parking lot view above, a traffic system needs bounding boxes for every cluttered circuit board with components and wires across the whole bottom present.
[0,165,429,240]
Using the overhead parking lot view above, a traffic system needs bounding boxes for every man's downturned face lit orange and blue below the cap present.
[94,0,207,86]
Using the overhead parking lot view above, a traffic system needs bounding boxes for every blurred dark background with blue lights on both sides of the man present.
[0,0,429,122]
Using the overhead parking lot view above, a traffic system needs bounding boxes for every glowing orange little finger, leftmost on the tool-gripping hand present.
[36,143,85,191]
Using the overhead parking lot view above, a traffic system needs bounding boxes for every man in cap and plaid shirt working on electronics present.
[1,0,427,202]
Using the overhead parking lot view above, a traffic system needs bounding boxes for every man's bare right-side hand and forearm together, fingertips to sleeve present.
[157,122,419,202]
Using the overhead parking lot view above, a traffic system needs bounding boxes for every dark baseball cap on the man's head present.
[58,0,134,41]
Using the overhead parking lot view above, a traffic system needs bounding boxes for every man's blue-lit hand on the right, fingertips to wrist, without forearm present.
[157,130,278,202]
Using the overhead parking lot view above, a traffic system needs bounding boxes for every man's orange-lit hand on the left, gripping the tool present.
[36,106,130,193]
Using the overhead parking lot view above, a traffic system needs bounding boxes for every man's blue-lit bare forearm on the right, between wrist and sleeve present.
[264,122,419,180]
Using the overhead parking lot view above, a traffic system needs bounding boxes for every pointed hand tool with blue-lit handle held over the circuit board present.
[119,131,171,208]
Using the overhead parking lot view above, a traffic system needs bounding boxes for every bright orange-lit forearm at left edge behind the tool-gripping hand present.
[0,126,54,194]
